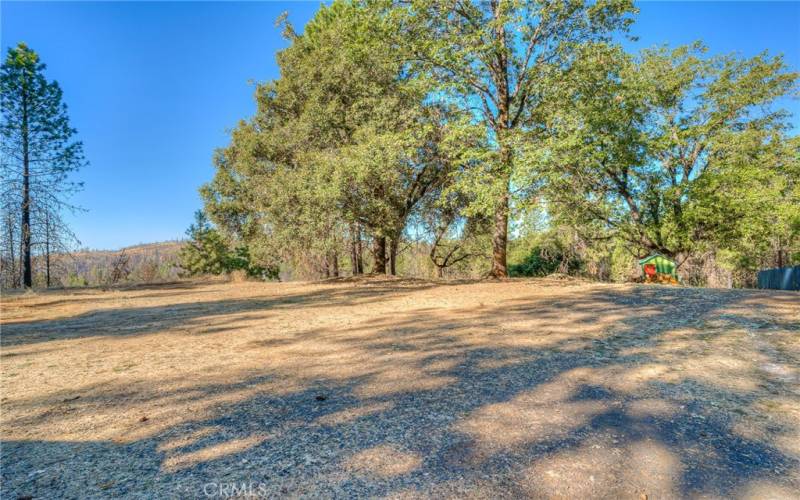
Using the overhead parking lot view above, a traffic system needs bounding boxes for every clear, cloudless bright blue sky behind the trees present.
[0,1,800,249]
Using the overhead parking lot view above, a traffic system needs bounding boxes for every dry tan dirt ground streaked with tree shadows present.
[0,279,800,499]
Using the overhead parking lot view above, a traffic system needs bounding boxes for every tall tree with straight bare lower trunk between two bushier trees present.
[389,0,635,277]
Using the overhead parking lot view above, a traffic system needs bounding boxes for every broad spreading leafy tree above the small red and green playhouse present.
[526,45,797,261]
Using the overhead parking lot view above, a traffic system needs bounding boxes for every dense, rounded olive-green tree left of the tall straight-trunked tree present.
[201,1,458,273]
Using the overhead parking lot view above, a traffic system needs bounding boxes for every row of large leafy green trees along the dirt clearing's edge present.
[191,0,800,283]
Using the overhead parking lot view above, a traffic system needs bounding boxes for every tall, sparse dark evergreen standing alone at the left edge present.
[0,43,86,287]
